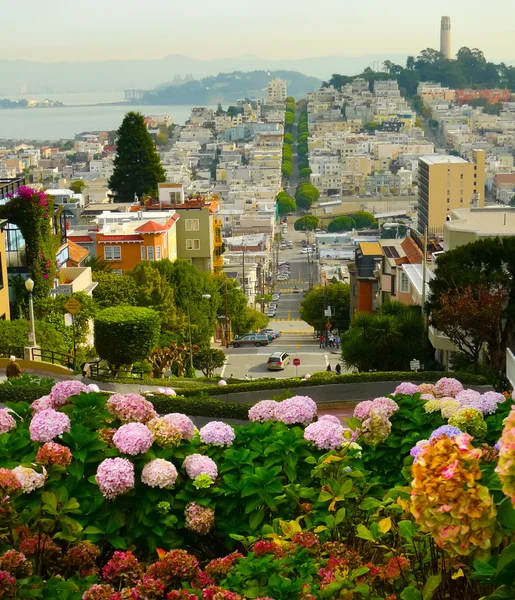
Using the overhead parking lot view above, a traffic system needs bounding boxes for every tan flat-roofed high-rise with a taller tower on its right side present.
[418,150,485,235]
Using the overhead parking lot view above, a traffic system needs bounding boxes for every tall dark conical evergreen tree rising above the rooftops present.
[109,112,166,202]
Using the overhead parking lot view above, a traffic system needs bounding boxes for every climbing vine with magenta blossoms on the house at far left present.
[0,186,61,297]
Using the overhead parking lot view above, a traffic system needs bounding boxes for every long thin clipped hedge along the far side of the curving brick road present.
[91,371,488,398]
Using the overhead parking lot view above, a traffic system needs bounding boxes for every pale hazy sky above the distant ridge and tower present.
[4,0,515,61]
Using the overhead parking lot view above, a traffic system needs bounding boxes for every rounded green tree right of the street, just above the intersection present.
[300,283,350,332]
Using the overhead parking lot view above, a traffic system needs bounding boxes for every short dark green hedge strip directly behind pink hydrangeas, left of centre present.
[148,388,250,421]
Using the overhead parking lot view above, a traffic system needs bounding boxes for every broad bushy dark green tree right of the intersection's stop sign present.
[341,302,425,371]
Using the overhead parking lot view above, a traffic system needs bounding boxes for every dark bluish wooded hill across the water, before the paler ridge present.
[138,71,322,104]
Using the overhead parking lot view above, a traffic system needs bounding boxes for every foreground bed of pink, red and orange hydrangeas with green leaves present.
[0,380,515,600]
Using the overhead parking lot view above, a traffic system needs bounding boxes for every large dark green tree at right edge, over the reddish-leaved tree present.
[428,237,515,373]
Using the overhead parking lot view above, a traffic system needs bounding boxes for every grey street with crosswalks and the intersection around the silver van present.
[221,223,339,379]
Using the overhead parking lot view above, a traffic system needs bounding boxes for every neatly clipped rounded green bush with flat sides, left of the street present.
[94,306,161,369]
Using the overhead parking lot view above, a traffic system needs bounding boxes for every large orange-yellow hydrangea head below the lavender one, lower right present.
[411,434,495,556]
